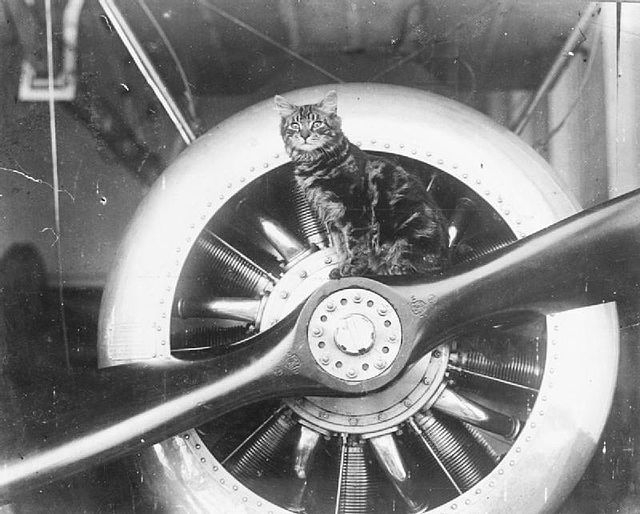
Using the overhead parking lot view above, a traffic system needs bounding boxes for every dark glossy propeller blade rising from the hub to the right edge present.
[386,186,640,360]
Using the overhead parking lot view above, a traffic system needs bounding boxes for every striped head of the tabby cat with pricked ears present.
[275,91,342,155]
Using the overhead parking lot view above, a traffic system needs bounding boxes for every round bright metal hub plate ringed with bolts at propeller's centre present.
[307,287,402,382]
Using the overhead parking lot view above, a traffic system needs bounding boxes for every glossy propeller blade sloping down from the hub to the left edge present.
[0,309,327,499]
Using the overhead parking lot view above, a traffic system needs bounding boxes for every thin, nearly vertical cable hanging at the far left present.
[44,0,71,371]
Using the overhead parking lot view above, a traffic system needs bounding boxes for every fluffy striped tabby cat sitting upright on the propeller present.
[275,91,447,276]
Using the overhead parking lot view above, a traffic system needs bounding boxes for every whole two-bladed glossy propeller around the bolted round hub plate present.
[0,187,640,499]
